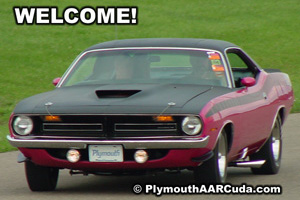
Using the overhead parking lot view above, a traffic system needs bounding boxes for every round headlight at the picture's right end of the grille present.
[182,116,202,135]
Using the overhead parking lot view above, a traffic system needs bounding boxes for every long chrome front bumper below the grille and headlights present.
[7,135,209,149]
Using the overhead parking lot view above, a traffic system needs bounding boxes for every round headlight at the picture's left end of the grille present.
[13,116,33,135]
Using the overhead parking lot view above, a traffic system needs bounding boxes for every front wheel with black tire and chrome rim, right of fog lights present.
[194,131,228,184]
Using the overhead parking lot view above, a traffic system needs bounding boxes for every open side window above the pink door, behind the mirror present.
[227,50,257,87]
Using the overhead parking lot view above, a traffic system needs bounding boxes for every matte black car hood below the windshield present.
[14,84,231,114]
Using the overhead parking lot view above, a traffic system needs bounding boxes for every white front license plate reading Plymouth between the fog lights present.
[89,145,124,162]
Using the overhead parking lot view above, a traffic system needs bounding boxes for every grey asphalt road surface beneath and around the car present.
[0,114,300,200]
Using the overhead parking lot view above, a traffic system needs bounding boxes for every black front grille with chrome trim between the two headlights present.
[34,115,184,138]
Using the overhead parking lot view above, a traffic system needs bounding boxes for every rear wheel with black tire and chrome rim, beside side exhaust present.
[249,117,282,174]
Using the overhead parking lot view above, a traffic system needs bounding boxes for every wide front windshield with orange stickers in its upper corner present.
[62,49,227,87]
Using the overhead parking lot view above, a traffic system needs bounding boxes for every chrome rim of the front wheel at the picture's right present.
[218,135,227,182]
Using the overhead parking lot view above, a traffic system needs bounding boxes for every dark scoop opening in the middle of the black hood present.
[96,90,141,98]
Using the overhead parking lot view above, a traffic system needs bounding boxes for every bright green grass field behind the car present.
[0,0,300,152]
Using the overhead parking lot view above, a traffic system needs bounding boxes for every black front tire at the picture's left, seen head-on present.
[25,161,59,191]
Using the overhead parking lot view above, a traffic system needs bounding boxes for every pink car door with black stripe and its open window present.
[226,48,272,154]
